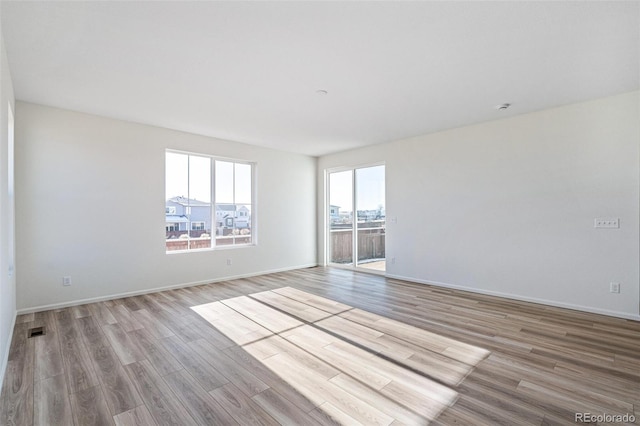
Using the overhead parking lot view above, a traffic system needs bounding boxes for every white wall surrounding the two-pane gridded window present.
[16,102,317,312]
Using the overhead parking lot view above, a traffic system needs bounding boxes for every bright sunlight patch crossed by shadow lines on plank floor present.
[191,287,490,425]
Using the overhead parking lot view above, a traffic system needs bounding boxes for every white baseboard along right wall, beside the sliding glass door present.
[386,274,640,321]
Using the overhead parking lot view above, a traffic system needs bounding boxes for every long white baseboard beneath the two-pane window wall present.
[17,263,318,315]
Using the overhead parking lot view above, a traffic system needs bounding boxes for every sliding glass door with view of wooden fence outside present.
[327,165,385,271]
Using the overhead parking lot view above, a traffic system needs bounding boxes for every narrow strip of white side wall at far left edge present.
[0,28,16,384]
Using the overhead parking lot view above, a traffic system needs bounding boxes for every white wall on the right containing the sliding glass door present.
[318,92,640,319]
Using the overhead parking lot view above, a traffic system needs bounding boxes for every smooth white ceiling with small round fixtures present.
[1,1,640,155]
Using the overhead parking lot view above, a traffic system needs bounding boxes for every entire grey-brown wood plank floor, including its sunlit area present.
[0,268,640,426]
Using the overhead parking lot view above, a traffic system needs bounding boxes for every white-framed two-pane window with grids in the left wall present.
[165,151,255,252]
